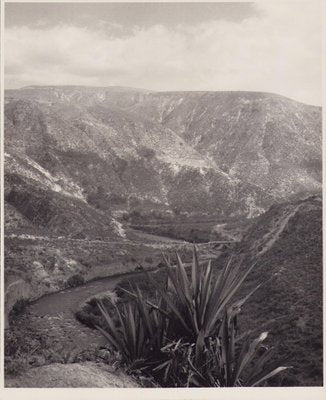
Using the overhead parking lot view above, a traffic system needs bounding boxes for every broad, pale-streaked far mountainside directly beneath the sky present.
[5,87,321,233]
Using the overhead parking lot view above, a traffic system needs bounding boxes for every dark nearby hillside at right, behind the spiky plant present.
[232,196,323,386]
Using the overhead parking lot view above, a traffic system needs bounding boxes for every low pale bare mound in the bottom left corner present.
[6,362,139,388]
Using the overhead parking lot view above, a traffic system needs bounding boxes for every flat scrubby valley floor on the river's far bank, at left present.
[5,230,199,326]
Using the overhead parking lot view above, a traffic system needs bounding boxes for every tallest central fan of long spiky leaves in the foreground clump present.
[148,247,260,357]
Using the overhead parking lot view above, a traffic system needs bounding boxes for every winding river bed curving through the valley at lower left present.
[5,235,220,379]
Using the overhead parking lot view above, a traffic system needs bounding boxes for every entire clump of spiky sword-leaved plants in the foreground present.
[97,248,287,387]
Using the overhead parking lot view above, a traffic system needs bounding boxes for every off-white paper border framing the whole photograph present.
[0,0,326,400]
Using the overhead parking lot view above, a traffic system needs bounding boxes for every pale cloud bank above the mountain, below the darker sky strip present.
[5,2,321,104]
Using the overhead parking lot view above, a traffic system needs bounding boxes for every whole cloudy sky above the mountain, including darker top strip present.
[5,0,321,105]
